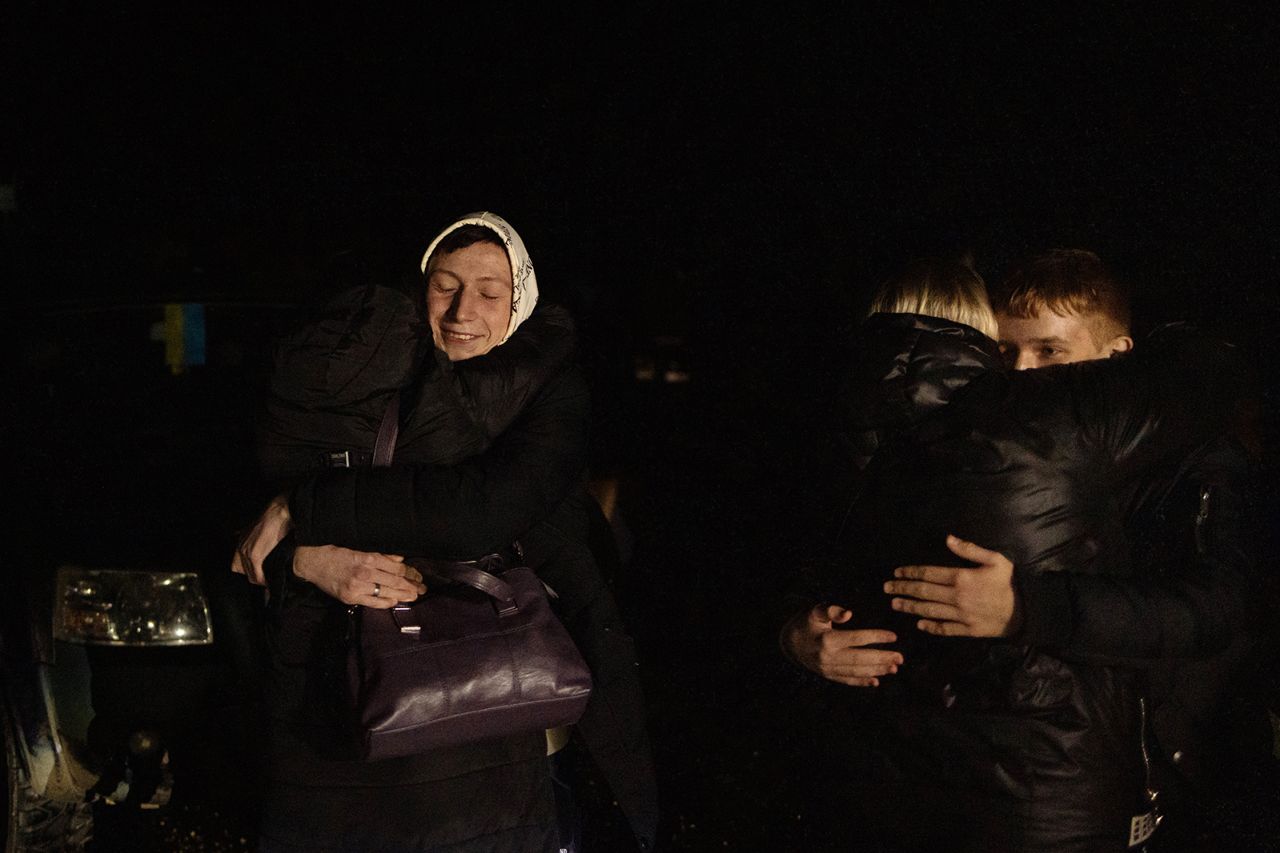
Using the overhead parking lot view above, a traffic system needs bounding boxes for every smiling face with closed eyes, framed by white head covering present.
[426,243,512,361]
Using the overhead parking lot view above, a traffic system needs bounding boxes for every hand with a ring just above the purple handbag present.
[293,546,426,610]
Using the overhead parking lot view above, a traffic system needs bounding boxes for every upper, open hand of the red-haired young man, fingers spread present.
[884,537,1021,637]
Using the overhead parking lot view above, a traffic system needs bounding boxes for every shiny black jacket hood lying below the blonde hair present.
[847,314,1004,429]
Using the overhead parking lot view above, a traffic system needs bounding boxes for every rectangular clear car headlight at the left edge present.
[54,566,214,646]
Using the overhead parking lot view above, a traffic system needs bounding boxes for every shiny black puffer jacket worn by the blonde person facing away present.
[824,315,1219,850]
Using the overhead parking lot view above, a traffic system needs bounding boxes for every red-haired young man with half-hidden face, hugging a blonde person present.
[782,250,1268,849]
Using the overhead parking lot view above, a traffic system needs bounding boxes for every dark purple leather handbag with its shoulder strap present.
[347,391,591,760]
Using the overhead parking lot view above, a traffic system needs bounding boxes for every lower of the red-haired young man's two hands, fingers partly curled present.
[780,605,902,686]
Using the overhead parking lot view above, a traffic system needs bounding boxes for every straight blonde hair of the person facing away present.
[868,257,998,339]
